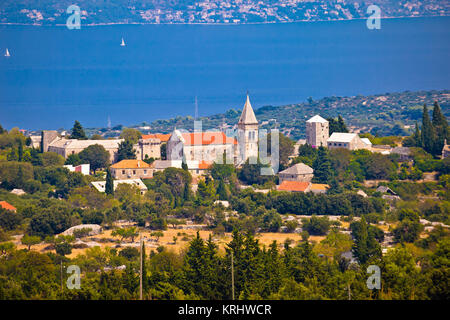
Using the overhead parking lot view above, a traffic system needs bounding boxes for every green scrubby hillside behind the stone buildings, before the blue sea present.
[96,90,450,139]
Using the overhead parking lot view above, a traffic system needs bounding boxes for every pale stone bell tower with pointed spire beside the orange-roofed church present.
[237,94,258,165]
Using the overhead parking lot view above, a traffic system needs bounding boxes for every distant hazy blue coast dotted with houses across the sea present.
[0,0,450,25]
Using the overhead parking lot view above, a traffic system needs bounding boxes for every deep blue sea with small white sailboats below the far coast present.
[0,18,450,129]
